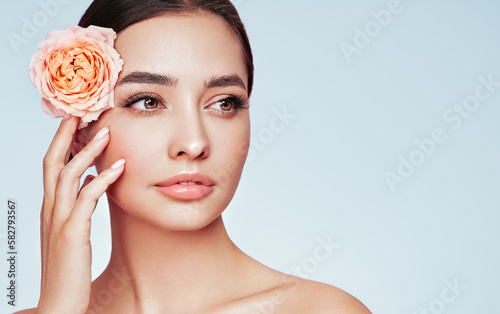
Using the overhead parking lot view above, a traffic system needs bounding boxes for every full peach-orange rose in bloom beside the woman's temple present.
[29,25,123,128]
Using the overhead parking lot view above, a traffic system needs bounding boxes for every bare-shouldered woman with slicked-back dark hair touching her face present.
[18,0,369,313]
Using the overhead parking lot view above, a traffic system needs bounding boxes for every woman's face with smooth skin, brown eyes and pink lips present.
[88,13,250,230]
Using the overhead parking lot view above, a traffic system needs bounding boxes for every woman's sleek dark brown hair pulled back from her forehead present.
[78,0,254,95]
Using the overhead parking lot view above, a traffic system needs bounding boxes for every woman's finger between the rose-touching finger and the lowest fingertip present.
[52,127,109,221]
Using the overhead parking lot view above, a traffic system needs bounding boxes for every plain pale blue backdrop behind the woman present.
[0,0,500,314]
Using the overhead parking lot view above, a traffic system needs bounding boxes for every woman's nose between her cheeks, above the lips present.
[168,106,209,159]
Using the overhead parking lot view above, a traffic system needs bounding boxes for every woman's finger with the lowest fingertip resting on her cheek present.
[68,159,125,224]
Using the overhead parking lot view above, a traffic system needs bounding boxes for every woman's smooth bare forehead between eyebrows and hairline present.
[115,12,247,79]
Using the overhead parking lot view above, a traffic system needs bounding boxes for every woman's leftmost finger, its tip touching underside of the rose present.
[43,117,79,211]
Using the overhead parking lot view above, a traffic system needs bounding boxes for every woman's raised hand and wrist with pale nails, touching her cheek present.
[37,117,125,314]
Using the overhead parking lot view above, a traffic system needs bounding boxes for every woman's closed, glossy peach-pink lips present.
[155,173,215,200]
